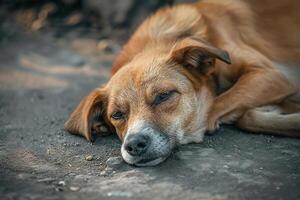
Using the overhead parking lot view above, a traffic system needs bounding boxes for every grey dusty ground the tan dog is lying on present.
[0,12,300,200]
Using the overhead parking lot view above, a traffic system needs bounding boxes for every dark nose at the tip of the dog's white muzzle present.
[125,134,150,156]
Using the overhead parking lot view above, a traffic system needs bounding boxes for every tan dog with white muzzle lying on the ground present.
[65,0,300,166]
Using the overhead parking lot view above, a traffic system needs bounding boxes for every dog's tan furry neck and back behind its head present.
[112,0,300,74]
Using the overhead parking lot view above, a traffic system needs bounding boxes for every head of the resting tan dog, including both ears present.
[65,39,230,166]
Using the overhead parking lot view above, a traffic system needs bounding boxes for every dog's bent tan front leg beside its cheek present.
[207,67,297,131]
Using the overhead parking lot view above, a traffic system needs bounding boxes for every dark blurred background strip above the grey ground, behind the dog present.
[1,0,193,40]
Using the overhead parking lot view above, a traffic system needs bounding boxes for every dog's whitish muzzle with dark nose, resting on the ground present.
[121,121,175,166]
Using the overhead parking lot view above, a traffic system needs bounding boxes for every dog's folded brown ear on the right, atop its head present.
[171,38,231,73]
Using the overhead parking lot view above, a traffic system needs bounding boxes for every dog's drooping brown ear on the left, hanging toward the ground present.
[65,88,108,141]
